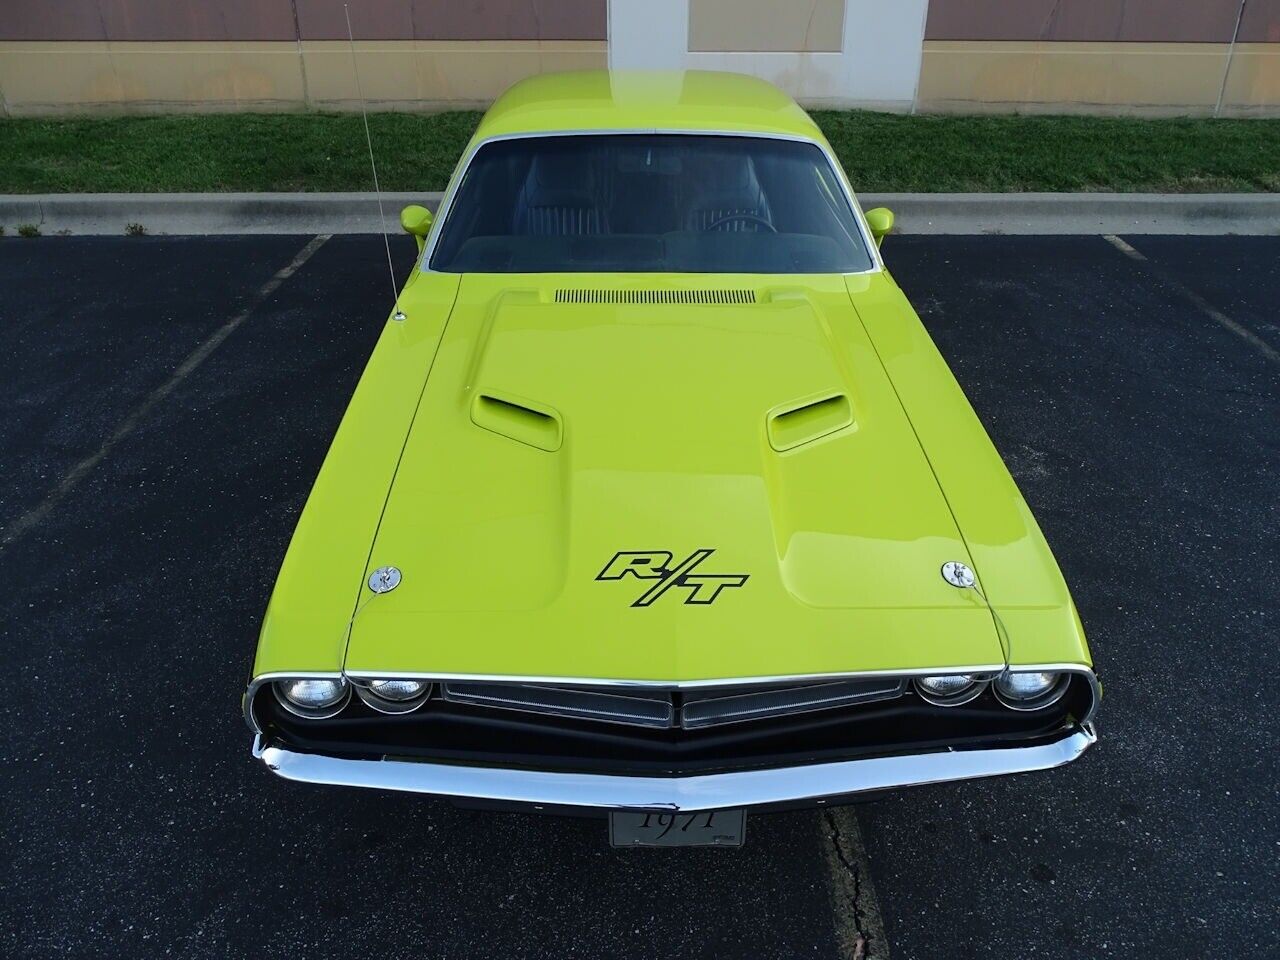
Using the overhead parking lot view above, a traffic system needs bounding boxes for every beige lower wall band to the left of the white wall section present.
[0,40,608,116]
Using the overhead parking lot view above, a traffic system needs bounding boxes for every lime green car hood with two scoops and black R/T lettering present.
[346,275,1001,682]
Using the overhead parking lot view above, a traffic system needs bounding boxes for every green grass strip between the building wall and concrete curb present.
[0,110,1280,193]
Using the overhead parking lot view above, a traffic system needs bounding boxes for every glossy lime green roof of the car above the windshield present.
[474,70,824,142]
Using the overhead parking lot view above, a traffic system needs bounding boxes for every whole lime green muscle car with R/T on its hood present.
[244,72,1101,842]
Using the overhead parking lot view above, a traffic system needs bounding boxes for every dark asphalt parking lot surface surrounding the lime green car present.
[0,237,1280,960]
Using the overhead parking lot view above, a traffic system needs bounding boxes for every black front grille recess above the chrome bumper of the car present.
[252,675,1092,776]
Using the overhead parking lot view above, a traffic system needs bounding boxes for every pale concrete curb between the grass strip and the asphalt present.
[0,192,1280,237]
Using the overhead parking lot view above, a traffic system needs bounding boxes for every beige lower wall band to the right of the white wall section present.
[916,40,1280,115]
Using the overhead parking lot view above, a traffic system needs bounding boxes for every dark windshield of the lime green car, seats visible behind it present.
[431,134,873,274]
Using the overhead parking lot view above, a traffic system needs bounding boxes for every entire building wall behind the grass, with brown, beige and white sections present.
[0,0,1280,116]
